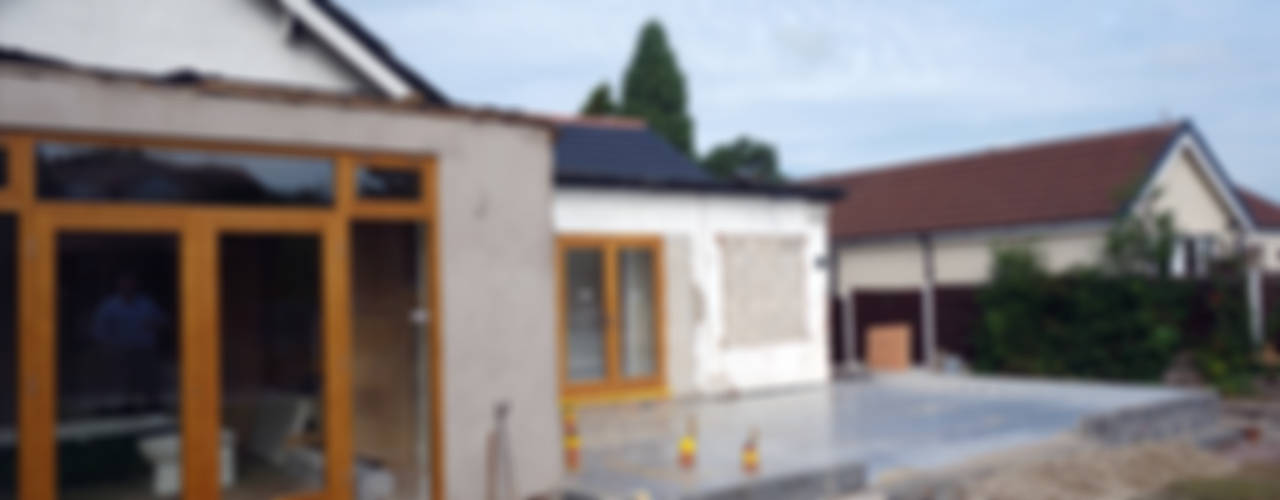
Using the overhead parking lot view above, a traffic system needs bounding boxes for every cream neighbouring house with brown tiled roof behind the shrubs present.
[812,121,1280,363]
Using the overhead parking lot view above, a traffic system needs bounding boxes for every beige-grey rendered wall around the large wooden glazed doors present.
[0,66,563,499]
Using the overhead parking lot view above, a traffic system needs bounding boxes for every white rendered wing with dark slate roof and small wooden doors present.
[553,119,840,402]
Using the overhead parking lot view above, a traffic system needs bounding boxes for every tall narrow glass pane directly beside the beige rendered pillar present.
[351,223,431,499]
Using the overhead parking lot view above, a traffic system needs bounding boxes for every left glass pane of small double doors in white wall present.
[564,248,604,381]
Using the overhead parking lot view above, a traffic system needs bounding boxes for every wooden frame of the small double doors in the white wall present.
[554,234,667,403]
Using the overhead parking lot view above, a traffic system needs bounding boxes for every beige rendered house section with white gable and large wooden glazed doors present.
[0,0,562,500]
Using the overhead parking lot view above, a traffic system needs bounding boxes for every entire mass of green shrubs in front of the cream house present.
[973,209,1260,394]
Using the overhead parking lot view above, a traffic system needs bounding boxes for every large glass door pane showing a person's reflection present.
[58,233,182,500]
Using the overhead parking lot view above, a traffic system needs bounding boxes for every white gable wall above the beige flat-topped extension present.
[0,0,365,92]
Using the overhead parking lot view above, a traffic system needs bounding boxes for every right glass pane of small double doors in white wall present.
[618,248,655,377]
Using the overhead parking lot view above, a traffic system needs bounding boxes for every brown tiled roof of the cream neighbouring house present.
[812,123,1187,239]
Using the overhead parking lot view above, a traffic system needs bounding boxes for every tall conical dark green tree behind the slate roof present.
[622,20,694,155]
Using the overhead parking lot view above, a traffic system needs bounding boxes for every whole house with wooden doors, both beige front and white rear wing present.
[0,0,838,500]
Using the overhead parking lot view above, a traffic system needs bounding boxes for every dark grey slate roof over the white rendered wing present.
[556,123,841,199]
